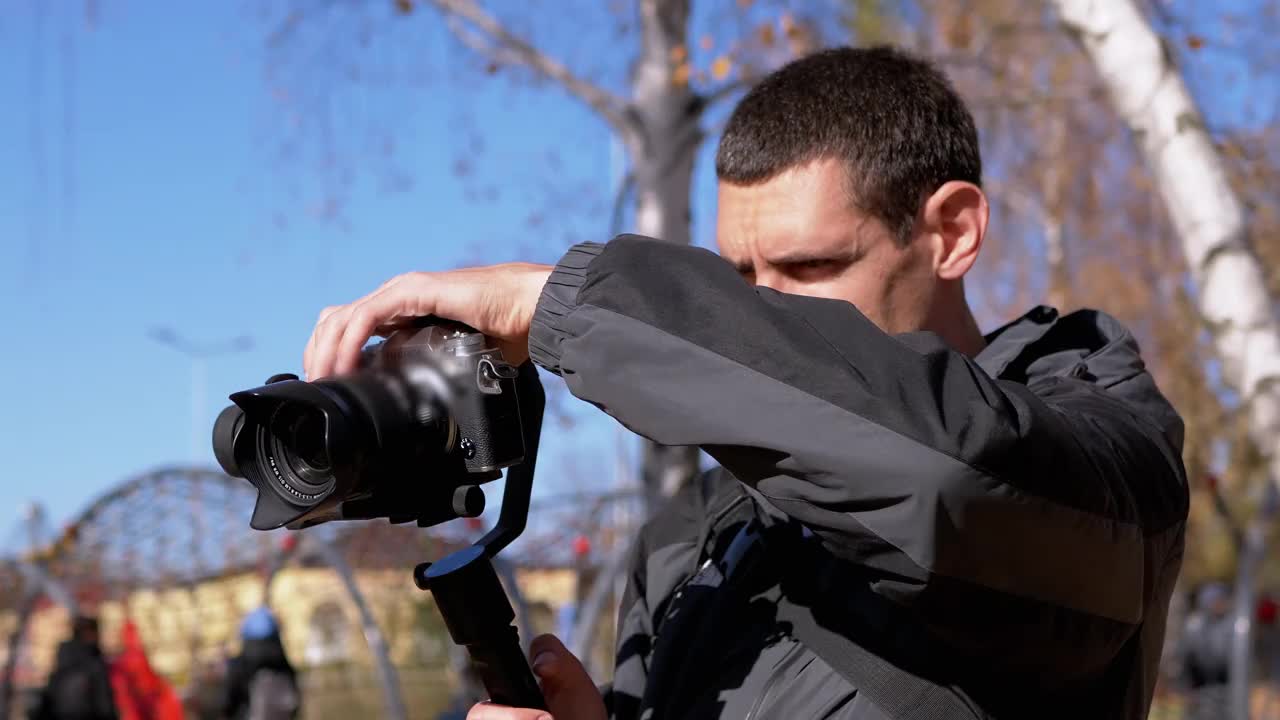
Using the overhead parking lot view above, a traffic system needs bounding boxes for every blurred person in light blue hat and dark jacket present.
[223,606,302,720]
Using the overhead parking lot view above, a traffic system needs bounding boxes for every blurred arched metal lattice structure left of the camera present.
[0,466,403,720]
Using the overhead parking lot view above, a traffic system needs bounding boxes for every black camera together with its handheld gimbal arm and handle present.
[214,316,547,708]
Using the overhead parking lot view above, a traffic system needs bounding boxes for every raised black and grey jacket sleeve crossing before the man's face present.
[530,236,1185,671]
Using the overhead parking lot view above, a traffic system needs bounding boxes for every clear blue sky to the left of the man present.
[0,1,732,539]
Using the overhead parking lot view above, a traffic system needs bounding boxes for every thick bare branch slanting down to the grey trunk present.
[431,0,627,132]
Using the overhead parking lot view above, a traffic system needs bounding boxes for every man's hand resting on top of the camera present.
[302,263,552,380]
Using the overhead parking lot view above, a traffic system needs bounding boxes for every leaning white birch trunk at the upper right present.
[1053,0,1280,483]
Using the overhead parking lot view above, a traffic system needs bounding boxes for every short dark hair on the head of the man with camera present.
[716,47,982,243]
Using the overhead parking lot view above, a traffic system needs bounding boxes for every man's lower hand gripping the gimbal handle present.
[467,635,605,720]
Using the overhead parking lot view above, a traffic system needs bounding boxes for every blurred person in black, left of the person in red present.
[31,616,118,720]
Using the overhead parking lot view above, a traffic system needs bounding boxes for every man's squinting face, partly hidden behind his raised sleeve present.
[716,160,938,333]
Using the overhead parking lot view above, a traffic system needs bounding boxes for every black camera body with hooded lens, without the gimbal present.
[214,318,526,529]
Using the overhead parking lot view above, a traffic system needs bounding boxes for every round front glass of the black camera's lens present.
[265,402,334,505]
